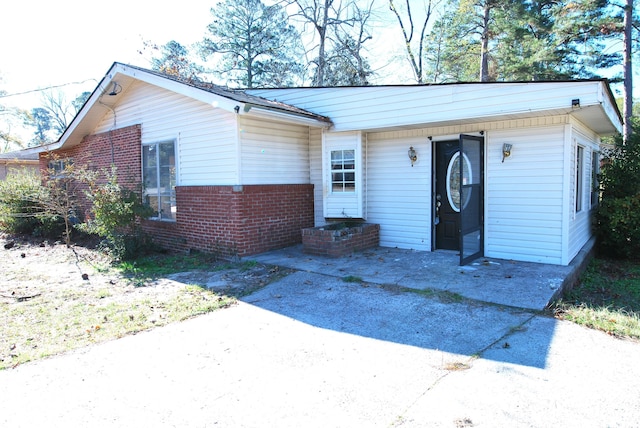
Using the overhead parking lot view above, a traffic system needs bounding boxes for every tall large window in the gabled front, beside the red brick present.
[142,141,177,220]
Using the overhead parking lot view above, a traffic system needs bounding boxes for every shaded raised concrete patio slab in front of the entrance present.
[247,242,593,310]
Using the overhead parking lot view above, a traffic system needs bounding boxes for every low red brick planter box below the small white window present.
[302,223,380,257]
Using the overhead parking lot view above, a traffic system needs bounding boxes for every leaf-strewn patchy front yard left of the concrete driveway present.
[0,236,292,369]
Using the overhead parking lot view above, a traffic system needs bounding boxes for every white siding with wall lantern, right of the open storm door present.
[485,126,564,264]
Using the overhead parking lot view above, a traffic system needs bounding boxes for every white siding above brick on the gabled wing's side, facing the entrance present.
[239,116,309,184]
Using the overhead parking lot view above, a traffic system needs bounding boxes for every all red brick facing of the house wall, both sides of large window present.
[40,125,314,256]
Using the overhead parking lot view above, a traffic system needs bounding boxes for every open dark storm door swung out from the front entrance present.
[458,134,484,265]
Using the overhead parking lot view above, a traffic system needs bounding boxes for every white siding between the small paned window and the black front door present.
[365,133,432,251]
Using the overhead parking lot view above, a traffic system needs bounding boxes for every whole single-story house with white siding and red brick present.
[41,63,622,265]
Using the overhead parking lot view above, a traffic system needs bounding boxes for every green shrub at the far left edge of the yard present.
[0,172,62,236]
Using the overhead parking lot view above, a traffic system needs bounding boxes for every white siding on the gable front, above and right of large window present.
[95,82,241,186]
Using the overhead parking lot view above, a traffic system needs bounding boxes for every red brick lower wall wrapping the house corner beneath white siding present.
[143,184,314,257]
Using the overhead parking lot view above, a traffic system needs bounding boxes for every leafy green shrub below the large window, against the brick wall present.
[78,168,153,260]
